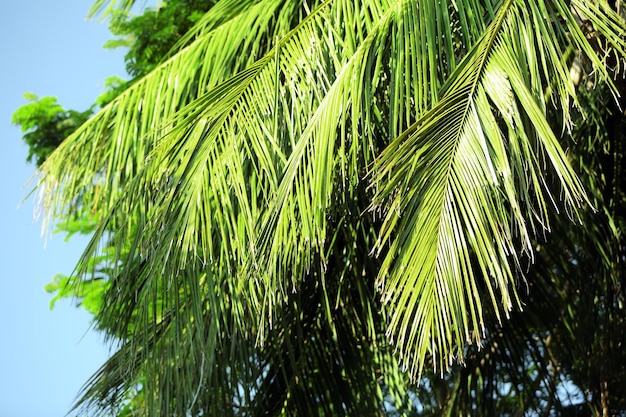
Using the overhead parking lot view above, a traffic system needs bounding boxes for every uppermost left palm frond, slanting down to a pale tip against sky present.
[40,0,299,231]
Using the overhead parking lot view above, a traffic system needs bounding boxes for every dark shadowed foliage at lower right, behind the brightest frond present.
[404,73,626,416]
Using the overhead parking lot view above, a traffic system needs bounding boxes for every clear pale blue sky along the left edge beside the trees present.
[0,0,125,417]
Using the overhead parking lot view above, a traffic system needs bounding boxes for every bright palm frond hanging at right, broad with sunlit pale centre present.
[373,1,620,375]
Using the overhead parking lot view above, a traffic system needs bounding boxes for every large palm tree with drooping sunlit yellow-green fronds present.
[37,0,626,416]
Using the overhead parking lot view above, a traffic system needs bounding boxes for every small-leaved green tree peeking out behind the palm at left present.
[13,0,213,322]
